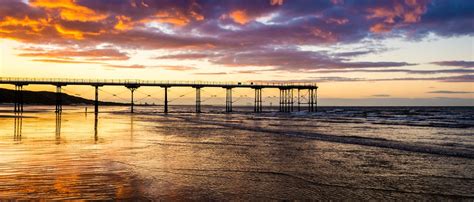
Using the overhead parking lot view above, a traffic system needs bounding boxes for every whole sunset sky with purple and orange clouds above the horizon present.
[0,0,474,106]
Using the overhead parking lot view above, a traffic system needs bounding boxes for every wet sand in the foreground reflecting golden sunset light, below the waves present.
[0,107,474,200]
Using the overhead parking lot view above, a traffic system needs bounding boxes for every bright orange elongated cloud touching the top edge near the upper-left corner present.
[30,0,107,22]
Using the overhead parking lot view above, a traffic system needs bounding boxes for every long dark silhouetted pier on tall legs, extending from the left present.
[0,78,318,113]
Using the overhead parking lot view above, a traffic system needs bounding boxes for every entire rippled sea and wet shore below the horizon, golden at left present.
[0,105,474,201]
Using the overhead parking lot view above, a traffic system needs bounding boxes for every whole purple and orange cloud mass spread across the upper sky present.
[0,0,474,74]
